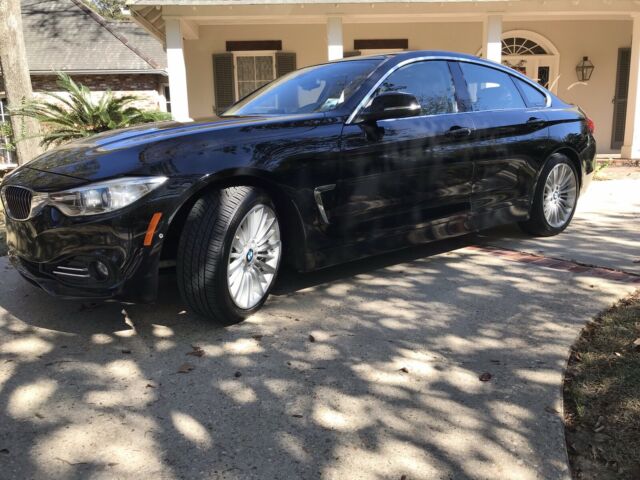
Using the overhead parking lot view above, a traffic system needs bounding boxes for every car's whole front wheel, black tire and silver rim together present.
[177,186,282,325]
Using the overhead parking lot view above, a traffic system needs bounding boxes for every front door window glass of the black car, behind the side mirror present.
[376,61,458,115]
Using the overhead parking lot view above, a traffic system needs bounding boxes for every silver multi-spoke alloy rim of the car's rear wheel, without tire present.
[542,163,577,228]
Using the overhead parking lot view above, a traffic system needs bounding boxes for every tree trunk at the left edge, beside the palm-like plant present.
[0,0,42,164]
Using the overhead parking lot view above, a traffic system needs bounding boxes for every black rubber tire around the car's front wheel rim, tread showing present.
[176,186,282,325]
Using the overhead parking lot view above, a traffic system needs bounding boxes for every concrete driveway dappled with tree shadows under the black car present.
[0,177,640,480]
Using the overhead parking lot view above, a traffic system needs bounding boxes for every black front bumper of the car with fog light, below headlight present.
[6,189,173,303]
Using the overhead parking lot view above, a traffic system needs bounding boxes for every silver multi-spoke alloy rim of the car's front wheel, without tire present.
[227,204,282,310]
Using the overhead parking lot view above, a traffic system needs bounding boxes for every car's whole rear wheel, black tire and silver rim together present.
[520,154,578,237]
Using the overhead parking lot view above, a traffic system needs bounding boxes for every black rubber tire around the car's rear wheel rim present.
[518,153,580,237]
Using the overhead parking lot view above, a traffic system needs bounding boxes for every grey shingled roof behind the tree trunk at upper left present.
[21,0,166,73]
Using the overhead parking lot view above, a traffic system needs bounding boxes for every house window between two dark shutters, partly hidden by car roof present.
[233,51,276,100]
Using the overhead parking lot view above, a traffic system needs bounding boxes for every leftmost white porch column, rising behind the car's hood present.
[164,18,191,122]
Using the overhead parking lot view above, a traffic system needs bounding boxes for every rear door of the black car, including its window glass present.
[456,61,549,228]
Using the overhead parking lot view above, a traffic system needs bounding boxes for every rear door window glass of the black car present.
[460,62,525,112]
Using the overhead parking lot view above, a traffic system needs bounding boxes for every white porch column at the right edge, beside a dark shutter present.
[621,15,640,160]
